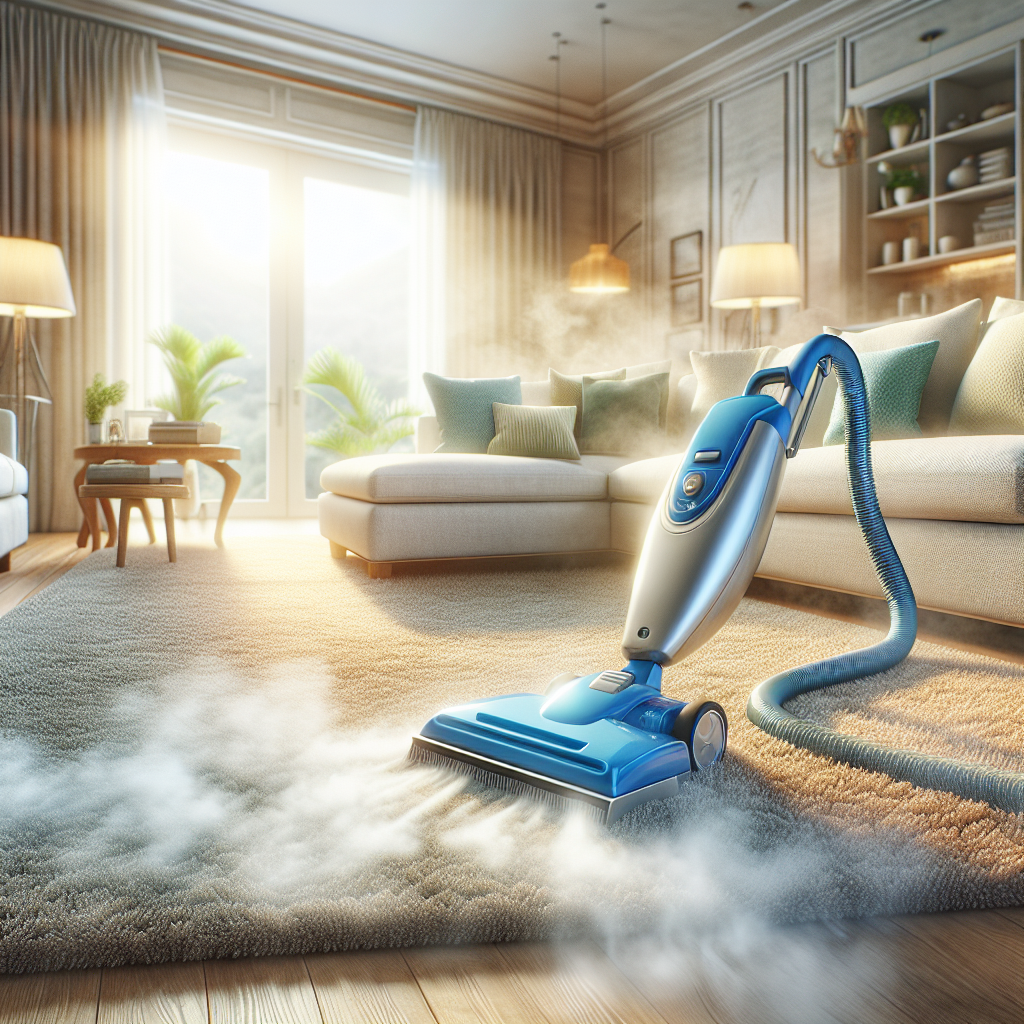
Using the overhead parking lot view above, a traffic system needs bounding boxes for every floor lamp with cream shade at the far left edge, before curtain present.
[0,238,76,464]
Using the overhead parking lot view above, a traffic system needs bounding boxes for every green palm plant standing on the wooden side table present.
[150,324,249,519]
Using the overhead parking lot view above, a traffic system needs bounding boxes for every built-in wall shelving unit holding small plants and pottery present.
[864,44,1021,316]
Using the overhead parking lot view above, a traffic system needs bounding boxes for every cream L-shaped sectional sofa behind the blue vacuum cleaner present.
[319,299,1024,626]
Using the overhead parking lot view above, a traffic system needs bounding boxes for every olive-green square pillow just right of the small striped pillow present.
[580,374,669,455]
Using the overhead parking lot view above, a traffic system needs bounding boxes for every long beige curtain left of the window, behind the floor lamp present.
[0,6,164,530]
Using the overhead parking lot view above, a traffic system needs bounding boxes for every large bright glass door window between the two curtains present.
[167,129,410,515]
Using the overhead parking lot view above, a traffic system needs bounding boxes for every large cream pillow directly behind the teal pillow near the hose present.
[818,299,981,437]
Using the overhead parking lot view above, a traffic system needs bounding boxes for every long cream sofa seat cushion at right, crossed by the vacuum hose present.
[778,436,1024,523]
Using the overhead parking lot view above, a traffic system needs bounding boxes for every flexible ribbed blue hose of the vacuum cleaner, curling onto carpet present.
[746,336,1024,813]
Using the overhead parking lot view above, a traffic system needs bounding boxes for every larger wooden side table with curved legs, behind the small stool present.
[75,441,242,551]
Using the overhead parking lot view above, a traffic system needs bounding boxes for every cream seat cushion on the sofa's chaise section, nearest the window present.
[321,453,625,504]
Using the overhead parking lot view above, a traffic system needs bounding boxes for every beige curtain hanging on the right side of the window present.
[411,108,561,401]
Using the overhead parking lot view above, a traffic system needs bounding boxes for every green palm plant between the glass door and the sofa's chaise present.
[302,347,420,459]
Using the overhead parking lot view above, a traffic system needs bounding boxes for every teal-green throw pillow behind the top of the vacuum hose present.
[824,341,939,444]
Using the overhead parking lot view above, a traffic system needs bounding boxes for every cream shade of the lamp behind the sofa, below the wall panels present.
[711,242,803,309]
